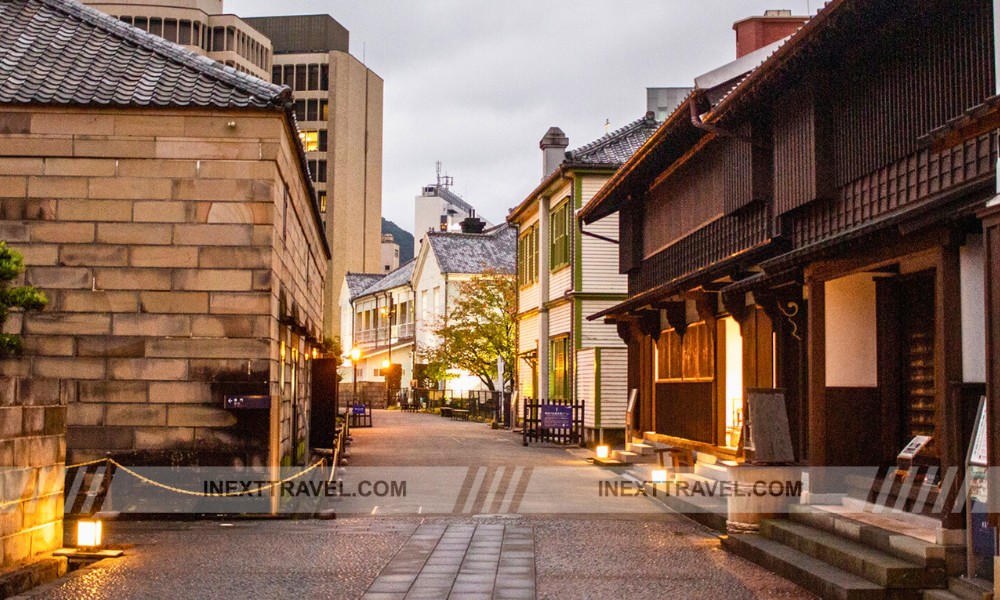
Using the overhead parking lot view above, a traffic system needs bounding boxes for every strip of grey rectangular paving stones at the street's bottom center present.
[363,523,535,600]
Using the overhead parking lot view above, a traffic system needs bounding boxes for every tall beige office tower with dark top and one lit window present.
[246,15,383,336]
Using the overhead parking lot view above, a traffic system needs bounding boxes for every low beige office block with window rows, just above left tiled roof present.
[84,0,272,80]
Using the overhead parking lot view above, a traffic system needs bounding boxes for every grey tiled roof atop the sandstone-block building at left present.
[0,0,291,108]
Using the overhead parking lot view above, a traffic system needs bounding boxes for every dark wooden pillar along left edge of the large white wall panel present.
[806,277,826,466]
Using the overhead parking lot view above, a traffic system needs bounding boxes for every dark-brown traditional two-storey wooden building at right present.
[581,0,996,482]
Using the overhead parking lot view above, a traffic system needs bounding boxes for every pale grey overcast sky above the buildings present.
[225,0,820,231]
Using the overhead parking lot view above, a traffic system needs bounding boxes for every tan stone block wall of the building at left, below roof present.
[0,107,327,464]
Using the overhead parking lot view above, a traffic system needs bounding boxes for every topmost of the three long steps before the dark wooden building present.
[788,504,954,568]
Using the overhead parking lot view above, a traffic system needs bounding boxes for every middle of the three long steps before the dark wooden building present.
[760,519,948,589]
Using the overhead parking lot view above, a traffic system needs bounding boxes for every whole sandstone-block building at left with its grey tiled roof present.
[0,0,330,563]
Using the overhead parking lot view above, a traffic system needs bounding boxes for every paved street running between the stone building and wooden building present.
[19,411,810,600]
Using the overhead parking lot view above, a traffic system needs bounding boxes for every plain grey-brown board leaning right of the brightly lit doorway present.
[740,388,795,464]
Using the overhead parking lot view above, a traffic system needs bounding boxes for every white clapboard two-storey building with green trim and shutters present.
[507,113,658,441]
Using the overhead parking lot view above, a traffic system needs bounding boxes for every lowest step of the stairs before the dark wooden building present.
[722,533,888,600]
